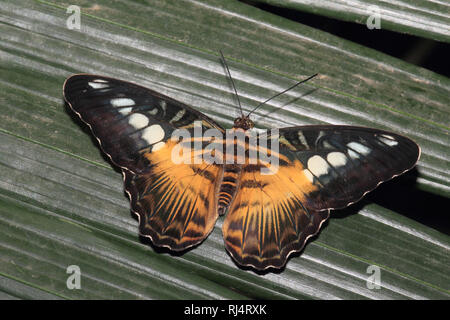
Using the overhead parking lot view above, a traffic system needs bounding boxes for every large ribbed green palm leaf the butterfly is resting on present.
[0,0,450,299]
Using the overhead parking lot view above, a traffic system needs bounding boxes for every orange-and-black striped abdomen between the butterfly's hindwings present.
[218,164,242,215]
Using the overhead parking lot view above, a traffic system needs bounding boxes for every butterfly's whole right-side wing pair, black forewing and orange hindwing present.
[222,125,420,270]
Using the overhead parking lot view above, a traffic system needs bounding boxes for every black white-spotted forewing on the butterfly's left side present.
[63,74,224,173]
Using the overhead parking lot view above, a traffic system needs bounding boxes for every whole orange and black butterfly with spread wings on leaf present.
[63,60,420,270]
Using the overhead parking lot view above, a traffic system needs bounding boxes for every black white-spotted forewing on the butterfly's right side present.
[279,125,420,210]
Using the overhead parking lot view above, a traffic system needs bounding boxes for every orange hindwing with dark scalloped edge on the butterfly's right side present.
[222,155,328,270]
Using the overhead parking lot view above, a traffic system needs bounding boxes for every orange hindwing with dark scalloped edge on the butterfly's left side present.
[125,140,222,251]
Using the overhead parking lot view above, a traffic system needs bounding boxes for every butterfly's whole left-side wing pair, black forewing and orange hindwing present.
[64,74,224,250]
